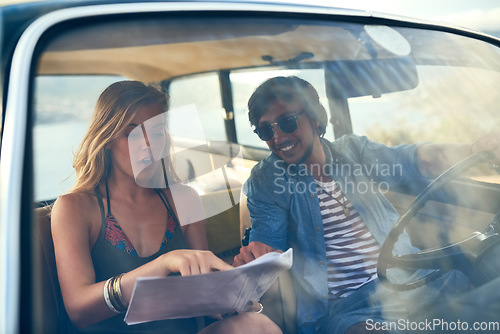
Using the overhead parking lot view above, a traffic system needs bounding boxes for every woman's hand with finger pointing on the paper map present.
[161,249,233,276]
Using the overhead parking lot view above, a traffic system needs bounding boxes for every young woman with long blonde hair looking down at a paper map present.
[52,81,280,334]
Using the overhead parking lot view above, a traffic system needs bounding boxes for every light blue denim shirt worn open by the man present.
[244,135,422,333]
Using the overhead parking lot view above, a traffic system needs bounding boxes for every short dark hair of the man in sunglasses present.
[248,76,328,137]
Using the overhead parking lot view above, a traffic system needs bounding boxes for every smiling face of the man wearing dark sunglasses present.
[259,100,321,164]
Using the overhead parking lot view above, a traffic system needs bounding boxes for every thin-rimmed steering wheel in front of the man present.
[377,152,500,291]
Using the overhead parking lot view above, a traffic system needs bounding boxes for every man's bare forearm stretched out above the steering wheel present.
[417,129,500,178]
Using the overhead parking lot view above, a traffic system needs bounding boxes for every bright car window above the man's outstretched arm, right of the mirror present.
[349,65,500,145]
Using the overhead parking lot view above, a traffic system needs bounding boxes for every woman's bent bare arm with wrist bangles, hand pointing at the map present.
[52,193,232,327]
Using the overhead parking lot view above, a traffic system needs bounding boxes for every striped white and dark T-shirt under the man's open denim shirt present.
[316,181,380,298]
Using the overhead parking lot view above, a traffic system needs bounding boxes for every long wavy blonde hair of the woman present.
[71,81,177,192]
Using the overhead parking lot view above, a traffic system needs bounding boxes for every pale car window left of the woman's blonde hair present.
[33,75,123,202]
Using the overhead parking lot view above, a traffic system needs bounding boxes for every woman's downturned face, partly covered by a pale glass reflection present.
[110,104,169,186]
